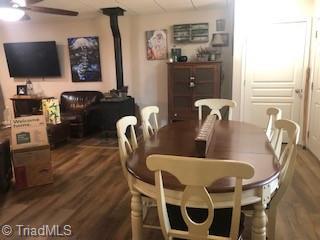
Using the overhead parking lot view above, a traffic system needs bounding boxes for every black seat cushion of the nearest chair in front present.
[167,204,245,237]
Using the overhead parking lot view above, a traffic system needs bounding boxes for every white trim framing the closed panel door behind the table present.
[232,17,312,143]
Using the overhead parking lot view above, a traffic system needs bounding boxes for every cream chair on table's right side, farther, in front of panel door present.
[266,107,282,158]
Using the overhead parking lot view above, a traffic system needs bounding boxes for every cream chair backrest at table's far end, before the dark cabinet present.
[194,98,237,120]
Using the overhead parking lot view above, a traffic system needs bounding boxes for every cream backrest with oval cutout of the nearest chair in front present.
[147,155,254,240]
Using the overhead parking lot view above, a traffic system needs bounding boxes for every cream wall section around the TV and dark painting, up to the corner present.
[0,16,131,109]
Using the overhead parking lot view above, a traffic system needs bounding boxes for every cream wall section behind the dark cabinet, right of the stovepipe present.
[131,8,232,124]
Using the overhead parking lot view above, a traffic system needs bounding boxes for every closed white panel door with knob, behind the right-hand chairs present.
[242,20,308,130]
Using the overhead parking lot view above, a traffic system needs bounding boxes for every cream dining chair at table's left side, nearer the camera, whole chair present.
[116,116,160,229]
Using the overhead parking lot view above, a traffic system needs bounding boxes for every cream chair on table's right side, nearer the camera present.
[267,120,300,240]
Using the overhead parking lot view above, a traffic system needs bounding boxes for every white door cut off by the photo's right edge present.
[308,18,320,159]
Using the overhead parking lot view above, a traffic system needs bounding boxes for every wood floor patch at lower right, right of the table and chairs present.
[277,149,320,240]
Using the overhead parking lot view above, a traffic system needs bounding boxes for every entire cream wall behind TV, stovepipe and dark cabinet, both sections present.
[0,8,232,124]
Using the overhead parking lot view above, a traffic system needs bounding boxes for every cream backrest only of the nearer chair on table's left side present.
[117,116,138,178]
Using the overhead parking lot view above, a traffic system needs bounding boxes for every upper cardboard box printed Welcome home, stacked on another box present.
[11,115,48,149]
